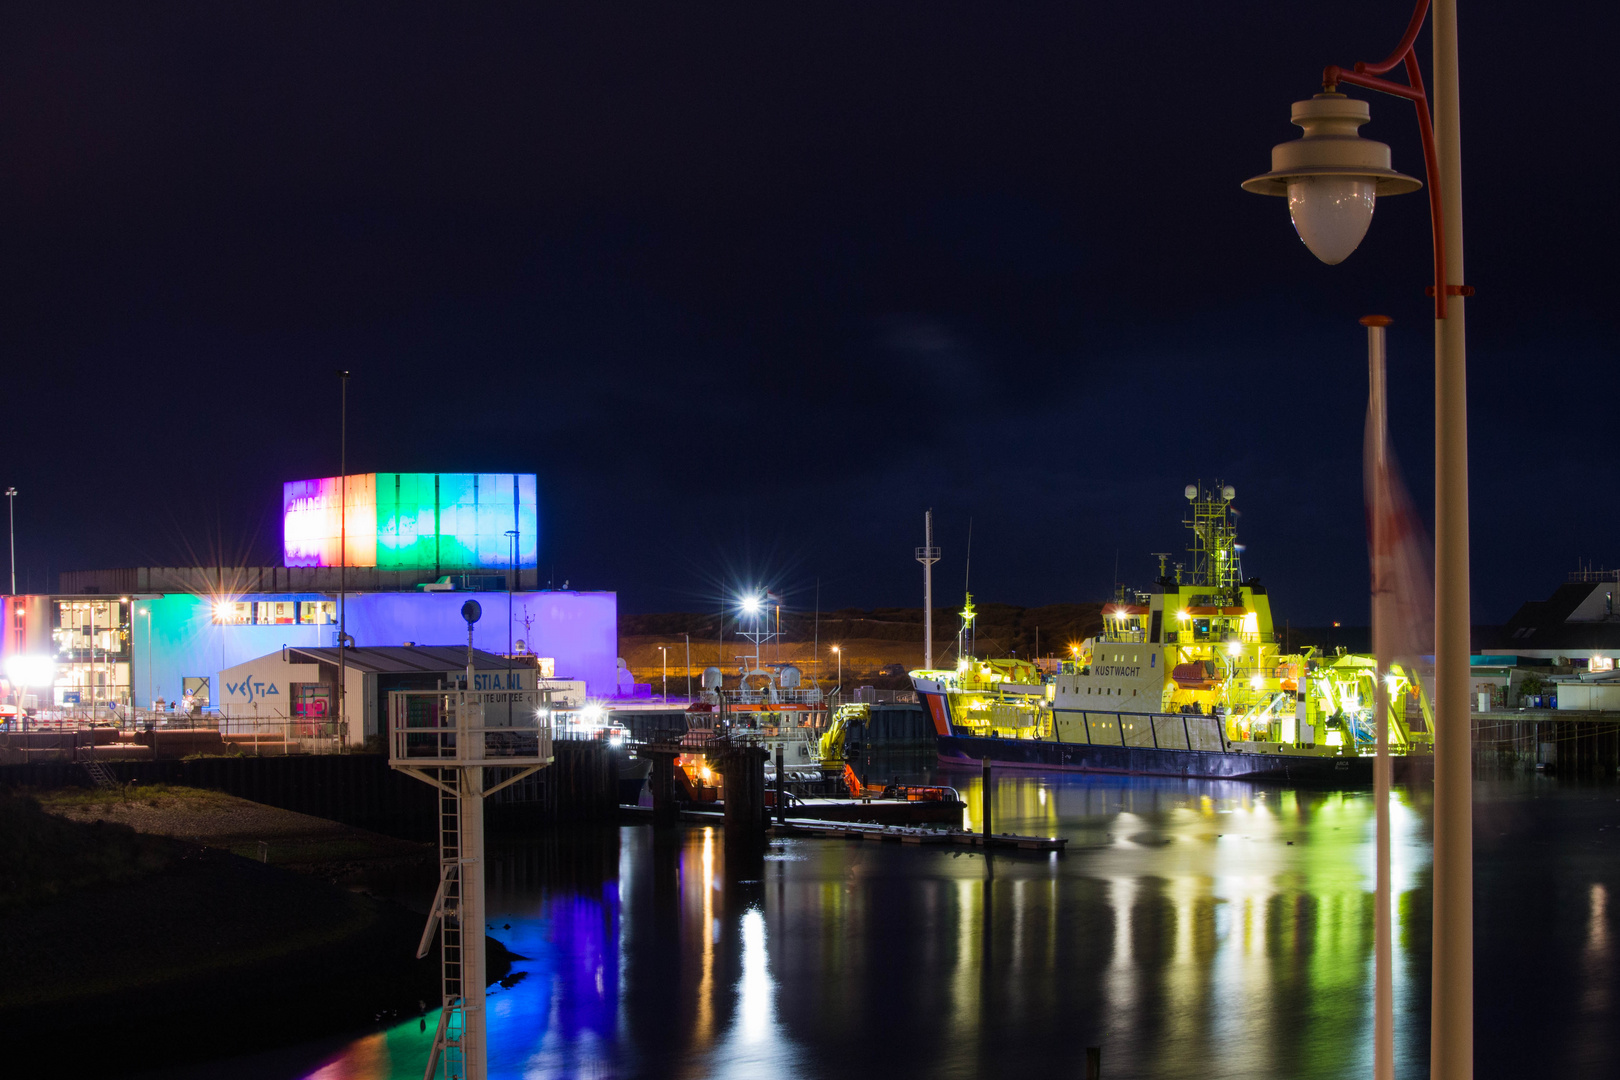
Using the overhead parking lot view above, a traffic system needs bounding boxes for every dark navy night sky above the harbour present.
[0,0,1620,625]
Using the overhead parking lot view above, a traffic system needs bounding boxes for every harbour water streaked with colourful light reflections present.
[291,774,1615,1080]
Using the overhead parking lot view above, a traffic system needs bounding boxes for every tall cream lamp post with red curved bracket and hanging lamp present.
[1243,0,1474,1080]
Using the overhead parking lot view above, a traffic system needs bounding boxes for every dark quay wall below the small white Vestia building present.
[0,742,620,840]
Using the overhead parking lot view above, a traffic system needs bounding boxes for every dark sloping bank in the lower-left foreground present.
[0,795,512,1075]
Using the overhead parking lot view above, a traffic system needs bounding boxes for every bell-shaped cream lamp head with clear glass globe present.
[1243,94,1422,266]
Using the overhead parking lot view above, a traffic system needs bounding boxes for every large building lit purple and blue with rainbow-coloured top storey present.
[0,473,619,711]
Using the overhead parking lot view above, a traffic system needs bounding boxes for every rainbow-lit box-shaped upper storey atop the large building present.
[282,473,539,570]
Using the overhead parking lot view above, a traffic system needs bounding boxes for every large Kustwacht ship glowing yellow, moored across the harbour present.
[910,483,1434,785]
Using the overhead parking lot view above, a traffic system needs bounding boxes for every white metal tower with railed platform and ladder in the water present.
[389,601,552,1080]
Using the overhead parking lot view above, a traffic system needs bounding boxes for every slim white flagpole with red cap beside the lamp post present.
[1361,316,1395,1080]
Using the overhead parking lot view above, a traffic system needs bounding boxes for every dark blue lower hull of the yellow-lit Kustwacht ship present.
[938,735,1432,787]
